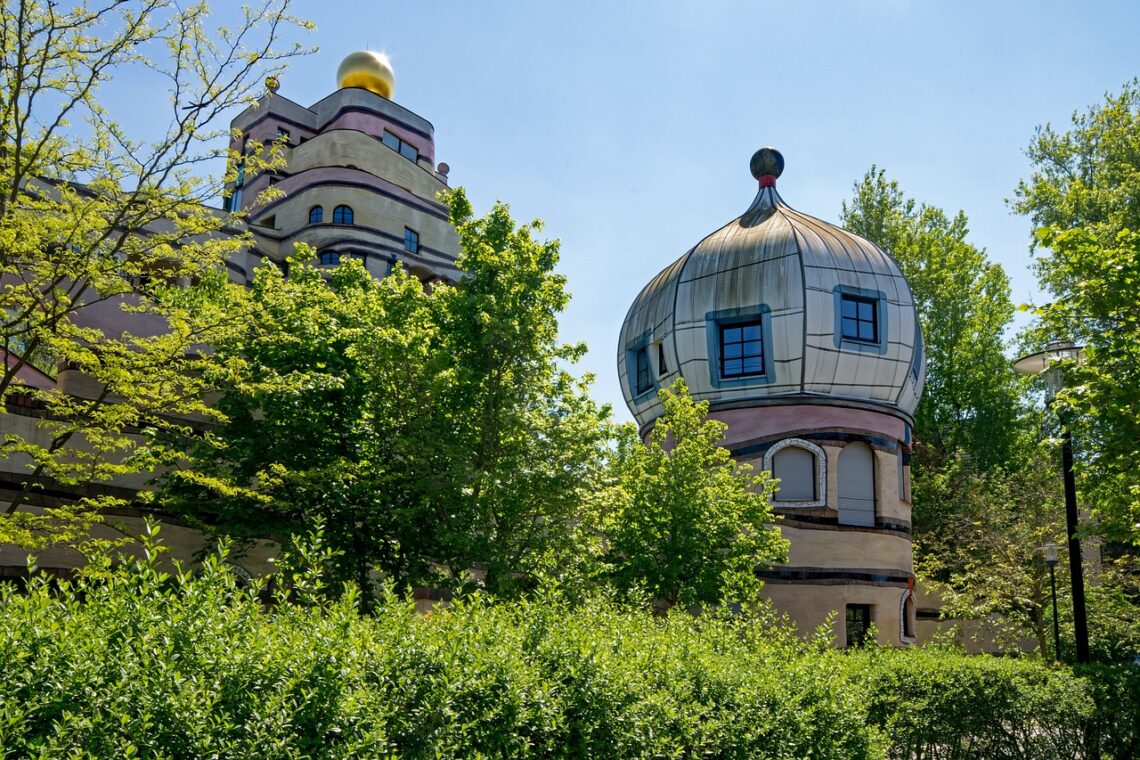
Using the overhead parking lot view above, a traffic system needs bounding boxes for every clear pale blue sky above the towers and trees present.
[129,0,1140,419]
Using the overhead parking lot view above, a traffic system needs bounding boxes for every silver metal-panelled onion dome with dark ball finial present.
[618,148,925,426]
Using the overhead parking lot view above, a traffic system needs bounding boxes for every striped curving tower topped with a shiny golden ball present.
[227,50,459,281]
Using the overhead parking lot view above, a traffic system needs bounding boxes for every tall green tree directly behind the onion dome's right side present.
[842,166,1020,476]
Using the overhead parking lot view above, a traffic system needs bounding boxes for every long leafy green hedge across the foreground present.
[0,533,1108,759]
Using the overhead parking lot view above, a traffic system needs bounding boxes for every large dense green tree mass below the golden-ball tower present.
[166,190,608,595]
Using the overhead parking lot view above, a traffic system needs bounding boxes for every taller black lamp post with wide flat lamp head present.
[1013,343,1089,662]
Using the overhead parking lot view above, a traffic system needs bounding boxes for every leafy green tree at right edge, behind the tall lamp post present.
[1012,79,1140,544]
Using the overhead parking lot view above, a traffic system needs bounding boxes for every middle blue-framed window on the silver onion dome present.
[705,304,775,387]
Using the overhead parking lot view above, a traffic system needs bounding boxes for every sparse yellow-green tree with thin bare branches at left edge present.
[0,0,307,546]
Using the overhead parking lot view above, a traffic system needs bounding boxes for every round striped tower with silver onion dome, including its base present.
[618,148,925,645]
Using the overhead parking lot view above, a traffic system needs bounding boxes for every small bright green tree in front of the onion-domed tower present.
[599,379,788,608]
